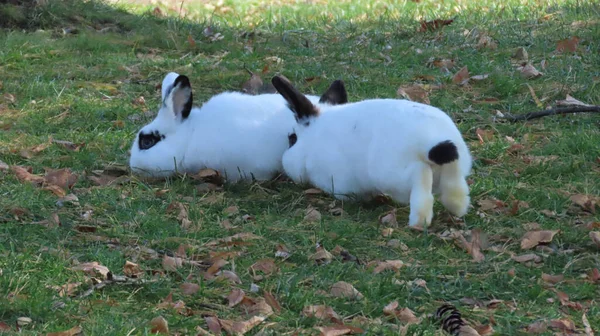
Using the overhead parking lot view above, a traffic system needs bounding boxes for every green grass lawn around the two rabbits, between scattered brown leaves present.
[0,0,600,335]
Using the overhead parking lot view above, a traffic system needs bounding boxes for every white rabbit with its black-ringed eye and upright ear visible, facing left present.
[129,72,347,182]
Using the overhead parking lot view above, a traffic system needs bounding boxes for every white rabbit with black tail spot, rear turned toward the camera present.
[272,76,472,226]
